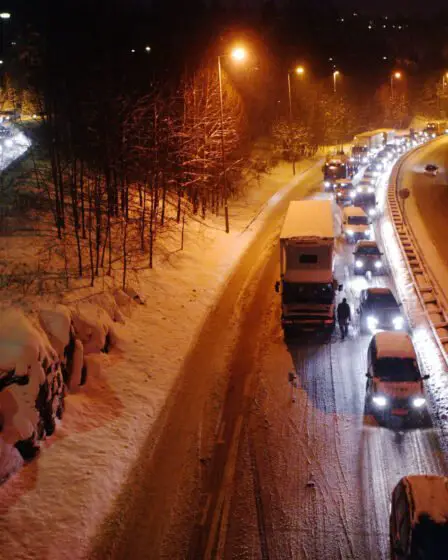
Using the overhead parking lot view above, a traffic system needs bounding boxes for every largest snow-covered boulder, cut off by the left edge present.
[0,308,65,460]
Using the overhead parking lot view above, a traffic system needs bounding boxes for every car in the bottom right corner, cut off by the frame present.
[389,474,448,560]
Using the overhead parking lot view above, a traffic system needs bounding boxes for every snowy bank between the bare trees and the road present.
[0,156,318,559]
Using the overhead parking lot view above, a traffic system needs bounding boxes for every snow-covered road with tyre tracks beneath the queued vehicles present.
[91,154,448,559]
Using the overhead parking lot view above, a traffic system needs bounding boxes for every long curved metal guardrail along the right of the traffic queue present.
[387,142,448,365]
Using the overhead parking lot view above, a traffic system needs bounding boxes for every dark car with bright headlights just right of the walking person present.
[357,288,409,333]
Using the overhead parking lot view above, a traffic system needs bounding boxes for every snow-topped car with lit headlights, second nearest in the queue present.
[366,331,429,419]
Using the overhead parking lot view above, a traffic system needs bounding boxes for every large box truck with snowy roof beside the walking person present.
[275,200,342,337]
